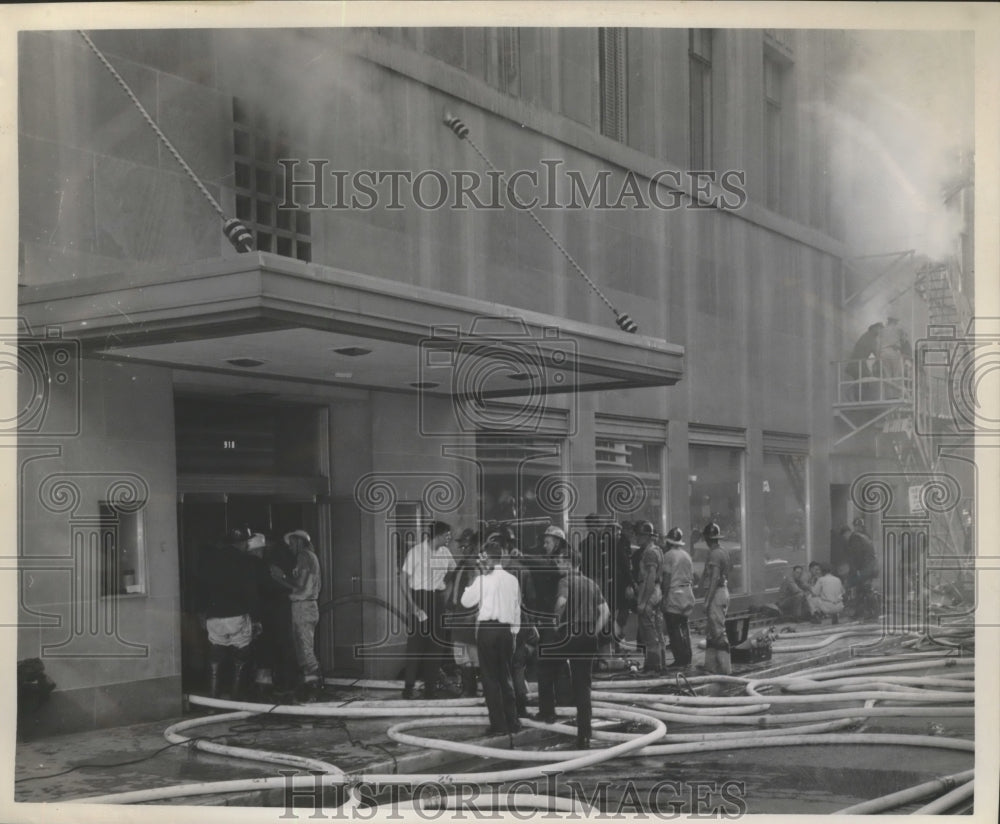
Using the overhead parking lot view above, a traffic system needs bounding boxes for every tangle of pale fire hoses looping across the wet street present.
[66,653,974,809]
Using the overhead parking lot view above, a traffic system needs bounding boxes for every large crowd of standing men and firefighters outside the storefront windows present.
[399,516,731,749]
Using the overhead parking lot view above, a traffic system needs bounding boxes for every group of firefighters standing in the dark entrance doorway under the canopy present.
[197,527,321,701]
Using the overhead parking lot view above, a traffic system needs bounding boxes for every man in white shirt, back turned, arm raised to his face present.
[462,541,521,735]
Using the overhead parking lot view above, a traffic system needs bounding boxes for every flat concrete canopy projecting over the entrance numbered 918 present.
[19,252,684,399]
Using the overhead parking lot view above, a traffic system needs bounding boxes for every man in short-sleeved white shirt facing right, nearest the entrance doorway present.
[399,521,456,698]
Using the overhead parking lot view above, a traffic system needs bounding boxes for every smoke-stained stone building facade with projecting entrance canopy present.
[18,28,968,731]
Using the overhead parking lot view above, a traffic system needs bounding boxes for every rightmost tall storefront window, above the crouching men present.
[754,450,809,589]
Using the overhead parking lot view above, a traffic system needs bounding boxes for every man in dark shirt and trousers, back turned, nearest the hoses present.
[538,548,611,750]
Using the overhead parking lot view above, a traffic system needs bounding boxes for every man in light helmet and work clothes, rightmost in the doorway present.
[271,529,321,701]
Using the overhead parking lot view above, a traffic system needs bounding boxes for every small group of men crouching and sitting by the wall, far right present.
[778,518,879,624]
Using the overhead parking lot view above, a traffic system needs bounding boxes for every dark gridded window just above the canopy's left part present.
[233,97,312,262]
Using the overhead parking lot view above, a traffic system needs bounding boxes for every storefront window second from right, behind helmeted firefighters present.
[688,444,745,592]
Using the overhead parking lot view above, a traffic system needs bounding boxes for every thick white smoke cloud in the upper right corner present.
[823,31,974,259]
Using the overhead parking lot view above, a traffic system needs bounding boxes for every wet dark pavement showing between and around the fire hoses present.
[15,623,975,817]
